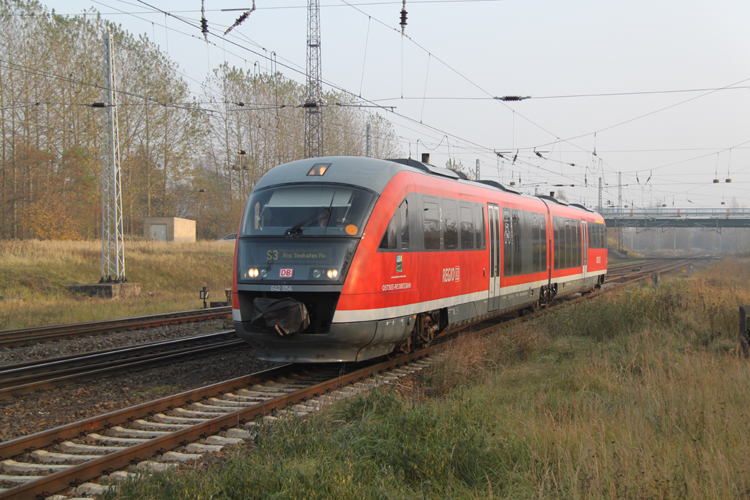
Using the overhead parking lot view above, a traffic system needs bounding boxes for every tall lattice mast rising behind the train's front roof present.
[304,0,323,158]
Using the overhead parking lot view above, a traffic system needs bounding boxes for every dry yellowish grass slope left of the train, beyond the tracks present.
[0,240,234,329]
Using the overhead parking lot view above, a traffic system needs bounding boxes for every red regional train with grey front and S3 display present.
[232,157,607,362]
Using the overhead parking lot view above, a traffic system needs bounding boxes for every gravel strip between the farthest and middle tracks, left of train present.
[0,319,234,367]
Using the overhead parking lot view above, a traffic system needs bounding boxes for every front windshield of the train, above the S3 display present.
[242,184,375,237]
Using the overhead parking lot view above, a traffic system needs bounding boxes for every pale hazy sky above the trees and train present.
[42,0,750,208]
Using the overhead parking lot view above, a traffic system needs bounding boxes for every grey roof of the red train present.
[255,156,596,217]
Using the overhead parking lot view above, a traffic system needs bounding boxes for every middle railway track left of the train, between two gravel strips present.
[0,330,246,399]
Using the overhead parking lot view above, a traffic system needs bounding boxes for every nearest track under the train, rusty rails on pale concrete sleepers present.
[0,261,704,499]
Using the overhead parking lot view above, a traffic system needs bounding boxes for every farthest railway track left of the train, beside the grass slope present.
[0,306,232,349]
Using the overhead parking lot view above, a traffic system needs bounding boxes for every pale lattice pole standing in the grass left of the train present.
[99,33,127,283]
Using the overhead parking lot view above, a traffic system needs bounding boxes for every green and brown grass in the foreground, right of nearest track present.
[108,259,750,499]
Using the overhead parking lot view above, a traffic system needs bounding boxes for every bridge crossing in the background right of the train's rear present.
[599,207,750,231]
